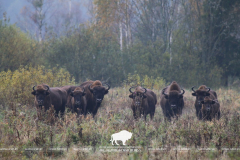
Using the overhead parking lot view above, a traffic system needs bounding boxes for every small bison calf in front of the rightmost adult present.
[201,96,220,121]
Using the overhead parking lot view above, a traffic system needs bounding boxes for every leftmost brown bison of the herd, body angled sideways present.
[32,84,67,116]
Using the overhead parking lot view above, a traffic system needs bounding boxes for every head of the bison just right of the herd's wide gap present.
[129,87,147,107]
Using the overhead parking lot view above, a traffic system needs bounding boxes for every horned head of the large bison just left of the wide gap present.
[88,83,110,104]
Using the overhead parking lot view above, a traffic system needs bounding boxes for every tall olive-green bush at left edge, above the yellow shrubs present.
[0,20,42,71]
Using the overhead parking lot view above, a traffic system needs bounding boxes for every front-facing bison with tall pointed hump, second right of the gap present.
[160,81,185,121]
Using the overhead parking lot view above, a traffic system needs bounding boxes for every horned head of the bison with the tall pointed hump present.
[162,88,185,109]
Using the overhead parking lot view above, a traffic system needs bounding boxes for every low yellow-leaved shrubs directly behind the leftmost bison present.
[0,66,75,105]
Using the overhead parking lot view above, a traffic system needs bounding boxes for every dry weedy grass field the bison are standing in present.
[0,87,240,160]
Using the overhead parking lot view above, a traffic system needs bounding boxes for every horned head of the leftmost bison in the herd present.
[32,85,50,106]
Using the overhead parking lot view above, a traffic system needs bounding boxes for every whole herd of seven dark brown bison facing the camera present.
[32,80,220,121]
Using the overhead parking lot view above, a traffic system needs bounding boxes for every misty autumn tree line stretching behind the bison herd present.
[0,0,240,87]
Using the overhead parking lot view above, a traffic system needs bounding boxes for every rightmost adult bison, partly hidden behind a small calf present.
[192,85,217,120]
